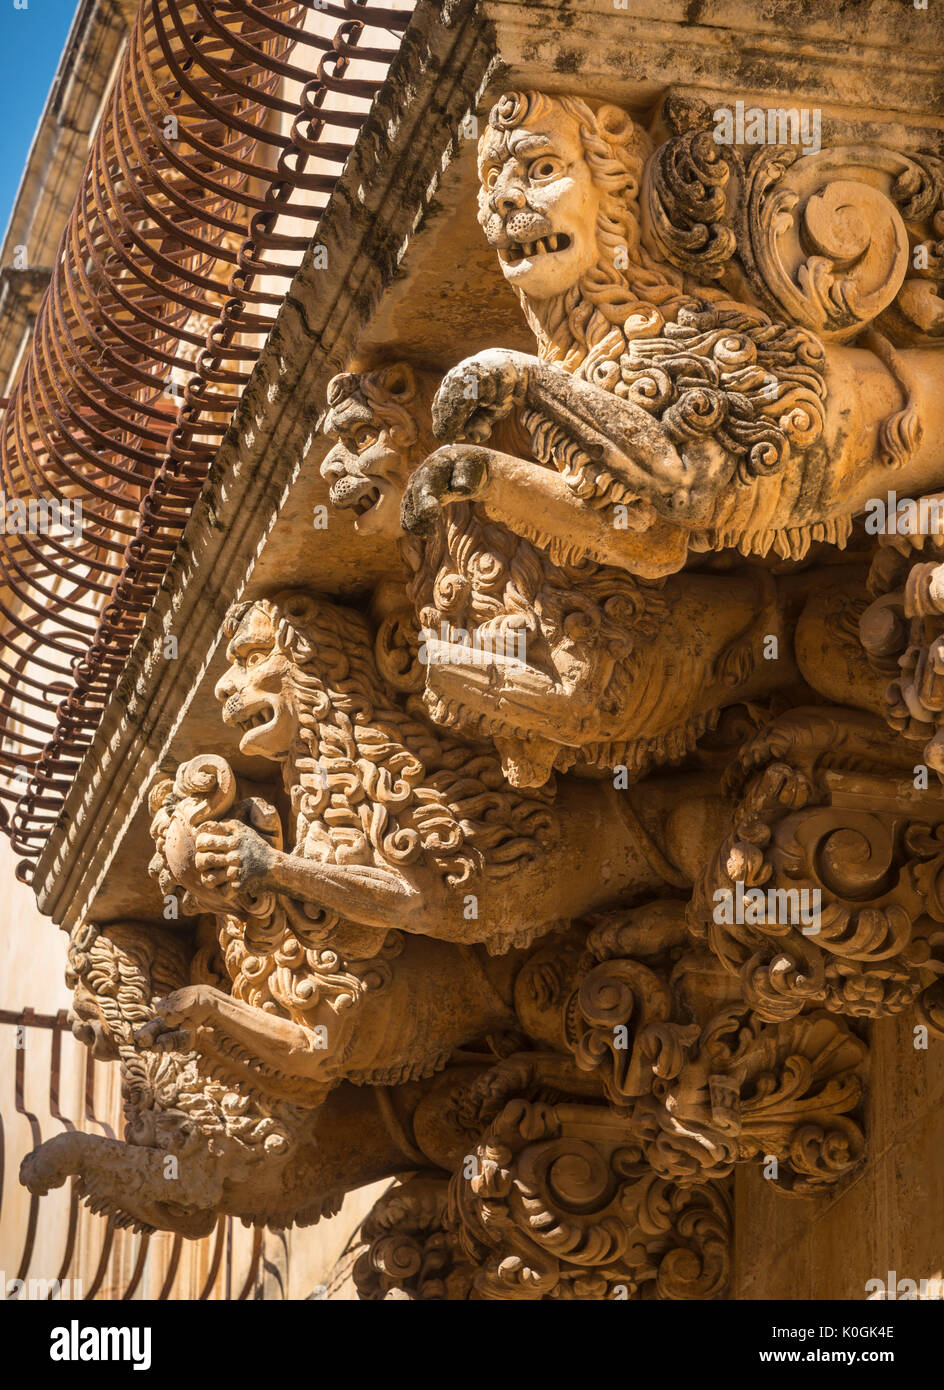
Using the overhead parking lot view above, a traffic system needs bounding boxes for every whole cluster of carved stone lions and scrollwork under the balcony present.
[22,92,944,1301]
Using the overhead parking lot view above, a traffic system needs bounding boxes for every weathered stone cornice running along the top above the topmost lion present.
[484,0,944,124]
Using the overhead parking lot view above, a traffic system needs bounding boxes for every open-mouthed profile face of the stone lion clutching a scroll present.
[214,606,298,762]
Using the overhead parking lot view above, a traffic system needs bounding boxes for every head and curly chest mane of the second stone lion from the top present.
[319,363,678,787]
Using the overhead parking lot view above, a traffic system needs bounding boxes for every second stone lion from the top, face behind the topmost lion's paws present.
[321,363,795,787]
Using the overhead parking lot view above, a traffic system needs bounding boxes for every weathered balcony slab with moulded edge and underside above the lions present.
[35,0,944,926]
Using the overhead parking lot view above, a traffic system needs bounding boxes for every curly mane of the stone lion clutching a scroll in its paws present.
[207,591,559,1023]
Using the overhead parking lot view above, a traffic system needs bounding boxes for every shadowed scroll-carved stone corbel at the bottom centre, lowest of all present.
[449,1098,730,1300]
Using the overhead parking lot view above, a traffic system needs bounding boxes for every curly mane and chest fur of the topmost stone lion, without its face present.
[489,92,828,557]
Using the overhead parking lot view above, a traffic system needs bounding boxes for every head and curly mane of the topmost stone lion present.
[478,84,826,505]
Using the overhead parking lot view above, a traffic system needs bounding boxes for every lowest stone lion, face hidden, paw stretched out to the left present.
[21,922,343,1238]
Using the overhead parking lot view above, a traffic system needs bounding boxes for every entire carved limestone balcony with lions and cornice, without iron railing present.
[16,3,944,1300]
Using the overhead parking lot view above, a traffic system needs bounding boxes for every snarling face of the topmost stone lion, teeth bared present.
[478,103,601,299]
